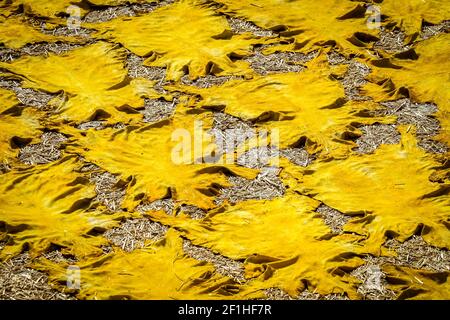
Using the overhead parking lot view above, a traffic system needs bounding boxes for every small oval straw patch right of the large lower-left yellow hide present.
[104,218,167,252]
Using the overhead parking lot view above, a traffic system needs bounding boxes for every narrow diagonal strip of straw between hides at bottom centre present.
[183,240,245,283]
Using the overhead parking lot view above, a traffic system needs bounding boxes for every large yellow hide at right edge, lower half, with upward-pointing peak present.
[283,128,450,254]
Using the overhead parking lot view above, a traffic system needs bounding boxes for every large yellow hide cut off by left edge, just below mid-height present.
[0,157,121,258]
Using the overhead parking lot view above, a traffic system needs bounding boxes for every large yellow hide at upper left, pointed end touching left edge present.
[0,42,160,123]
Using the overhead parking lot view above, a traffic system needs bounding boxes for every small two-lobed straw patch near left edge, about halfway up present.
[18,132,67,165]
